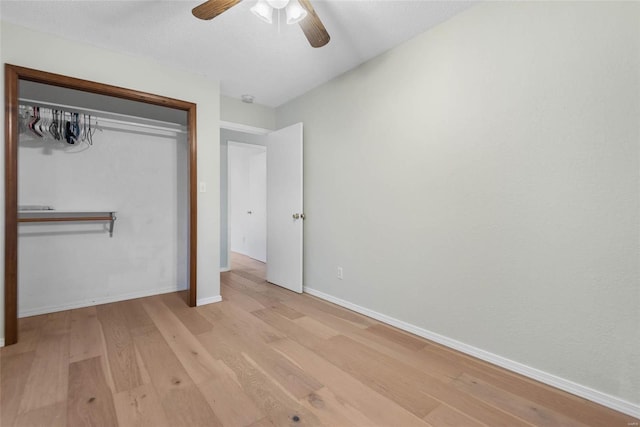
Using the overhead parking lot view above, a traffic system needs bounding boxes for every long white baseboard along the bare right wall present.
[304,286,640,418]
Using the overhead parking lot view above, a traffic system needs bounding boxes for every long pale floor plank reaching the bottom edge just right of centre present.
[269,339,427,427]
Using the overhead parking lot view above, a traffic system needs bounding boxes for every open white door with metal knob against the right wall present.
[267,123,304,292]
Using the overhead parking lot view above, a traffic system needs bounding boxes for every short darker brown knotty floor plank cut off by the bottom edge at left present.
[67,356,118,427]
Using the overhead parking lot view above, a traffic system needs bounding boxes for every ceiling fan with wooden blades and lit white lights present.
[191,0,330,47]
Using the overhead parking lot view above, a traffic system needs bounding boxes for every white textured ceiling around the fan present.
[0,0,473,107]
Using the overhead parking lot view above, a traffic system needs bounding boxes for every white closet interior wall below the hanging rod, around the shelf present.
[18,118,188,317]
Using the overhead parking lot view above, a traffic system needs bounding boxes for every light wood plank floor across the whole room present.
[0,255,638,427]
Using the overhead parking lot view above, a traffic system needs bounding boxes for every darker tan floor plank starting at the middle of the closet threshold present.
[97,303,143,393]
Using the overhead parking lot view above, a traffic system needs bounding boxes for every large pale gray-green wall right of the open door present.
[277,2,640,408]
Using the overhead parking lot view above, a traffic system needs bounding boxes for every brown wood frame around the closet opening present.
[4,64,198,345]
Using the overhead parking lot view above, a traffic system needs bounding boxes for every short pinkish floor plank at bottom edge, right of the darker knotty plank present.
[113,384,170,427]
